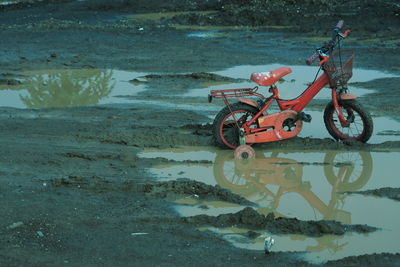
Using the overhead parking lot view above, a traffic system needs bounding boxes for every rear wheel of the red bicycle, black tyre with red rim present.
[213,103,258,148]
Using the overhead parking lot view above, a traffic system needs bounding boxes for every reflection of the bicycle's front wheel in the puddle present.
[324,152,373,192]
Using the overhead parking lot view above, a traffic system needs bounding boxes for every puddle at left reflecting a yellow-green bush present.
[0,69,145,108]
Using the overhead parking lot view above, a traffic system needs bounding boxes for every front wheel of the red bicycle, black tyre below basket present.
[324,100,373,143]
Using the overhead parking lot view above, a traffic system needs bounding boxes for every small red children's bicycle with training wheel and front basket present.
[208,20,373,157]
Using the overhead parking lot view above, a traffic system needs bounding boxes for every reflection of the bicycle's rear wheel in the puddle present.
[213,151,259,196]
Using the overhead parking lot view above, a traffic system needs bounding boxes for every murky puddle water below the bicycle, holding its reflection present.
[141,147,400,262]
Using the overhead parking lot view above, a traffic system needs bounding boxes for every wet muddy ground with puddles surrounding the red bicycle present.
[0,1,400,266]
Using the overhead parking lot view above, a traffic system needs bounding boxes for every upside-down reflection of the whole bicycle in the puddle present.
[213,151,373,252]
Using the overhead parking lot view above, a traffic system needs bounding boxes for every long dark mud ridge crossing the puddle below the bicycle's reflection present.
[182,207,377,236]
